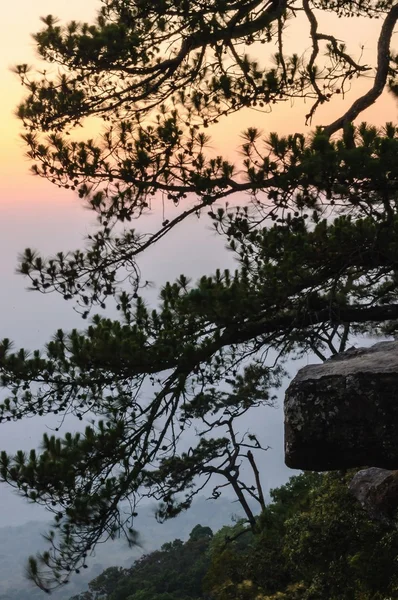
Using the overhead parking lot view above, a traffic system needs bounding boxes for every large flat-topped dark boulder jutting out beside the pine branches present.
[285,341,398,471]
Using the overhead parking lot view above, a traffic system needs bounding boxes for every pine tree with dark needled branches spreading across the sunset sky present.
[0,0,398,591]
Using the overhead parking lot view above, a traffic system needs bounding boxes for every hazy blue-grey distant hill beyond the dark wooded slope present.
[0,497,262,600]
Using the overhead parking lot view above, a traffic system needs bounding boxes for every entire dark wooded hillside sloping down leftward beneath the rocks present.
[76,473,398,600]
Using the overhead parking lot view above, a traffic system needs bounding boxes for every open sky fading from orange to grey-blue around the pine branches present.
[0,0,397,526]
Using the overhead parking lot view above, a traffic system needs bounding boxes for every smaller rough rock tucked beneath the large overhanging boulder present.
[349,467,398,525]
